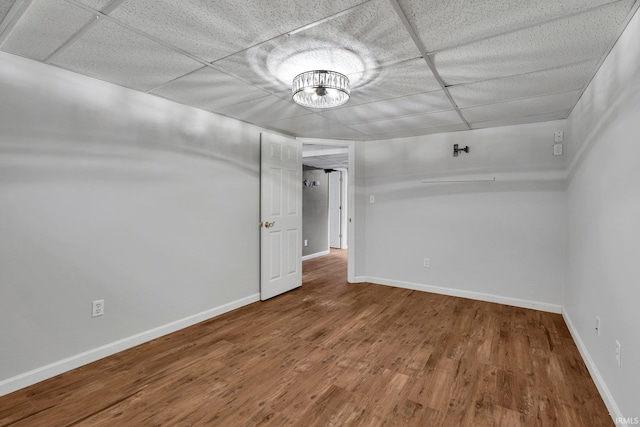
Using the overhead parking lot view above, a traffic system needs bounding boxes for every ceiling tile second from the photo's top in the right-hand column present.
[432,0,634,85]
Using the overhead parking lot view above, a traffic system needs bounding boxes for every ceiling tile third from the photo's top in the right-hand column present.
[449,60,598,108]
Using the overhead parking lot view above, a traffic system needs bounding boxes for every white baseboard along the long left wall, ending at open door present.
[0,294,260,396]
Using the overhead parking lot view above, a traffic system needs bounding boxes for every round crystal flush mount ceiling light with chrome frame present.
[292,70,351,108]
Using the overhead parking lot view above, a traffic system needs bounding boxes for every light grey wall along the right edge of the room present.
[565,7,640,419]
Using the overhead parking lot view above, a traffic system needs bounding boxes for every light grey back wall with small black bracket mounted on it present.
[358,121,566,312]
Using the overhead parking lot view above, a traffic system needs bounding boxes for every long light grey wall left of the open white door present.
[0,53,260,392]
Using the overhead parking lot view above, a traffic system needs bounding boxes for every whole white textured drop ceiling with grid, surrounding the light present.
[0,0,640,140]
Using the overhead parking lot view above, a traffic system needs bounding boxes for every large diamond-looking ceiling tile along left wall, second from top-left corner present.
[52,19,202,91]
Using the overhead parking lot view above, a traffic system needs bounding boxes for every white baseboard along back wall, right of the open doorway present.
[365,277,562,314]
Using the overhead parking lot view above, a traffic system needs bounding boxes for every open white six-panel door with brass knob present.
[260,133,302,301]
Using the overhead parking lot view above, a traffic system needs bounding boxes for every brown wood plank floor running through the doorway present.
[0,250,613,427]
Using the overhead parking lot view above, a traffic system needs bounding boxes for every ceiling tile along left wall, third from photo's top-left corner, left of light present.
[151,66,267,110]
